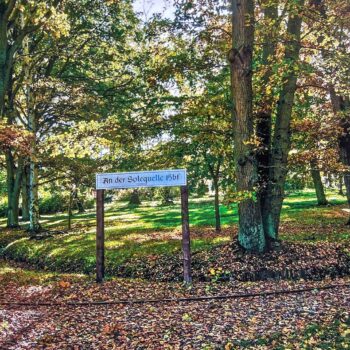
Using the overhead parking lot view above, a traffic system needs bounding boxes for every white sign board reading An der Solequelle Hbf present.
[96,169,187,190]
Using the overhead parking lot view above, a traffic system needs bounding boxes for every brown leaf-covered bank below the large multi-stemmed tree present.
[118,240,350,281]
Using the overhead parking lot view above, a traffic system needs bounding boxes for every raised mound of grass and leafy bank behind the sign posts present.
[0,191,350,280]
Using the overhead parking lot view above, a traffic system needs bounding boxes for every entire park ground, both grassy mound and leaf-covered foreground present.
[0,191,350,350]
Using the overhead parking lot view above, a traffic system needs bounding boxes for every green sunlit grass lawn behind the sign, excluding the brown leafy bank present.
[0,191,350,273]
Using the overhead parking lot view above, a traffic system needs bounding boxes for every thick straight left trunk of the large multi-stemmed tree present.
[229,0,265,252]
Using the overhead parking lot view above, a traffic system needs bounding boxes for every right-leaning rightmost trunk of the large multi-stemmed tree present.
[262,0,304,245]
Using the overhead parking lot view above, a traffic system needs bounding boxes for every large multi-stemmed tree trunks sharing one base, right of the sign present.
[229,0,304,252]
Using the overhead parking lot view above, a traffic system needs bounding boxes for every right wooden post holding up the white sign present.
[181,186,192,283]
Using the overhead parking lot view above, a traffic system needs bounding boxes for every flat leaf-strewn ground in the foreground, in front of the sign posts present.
[0,263,350,350]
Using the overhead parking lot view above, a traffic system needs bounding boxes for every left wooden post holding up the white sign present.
[96,190,105,283]
